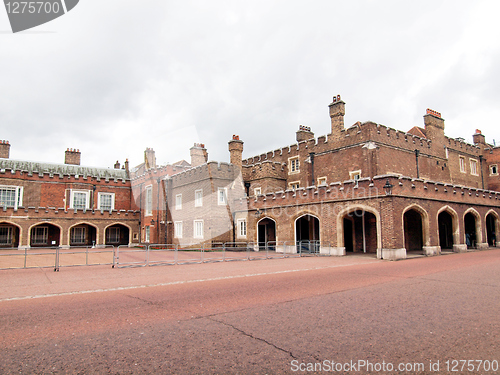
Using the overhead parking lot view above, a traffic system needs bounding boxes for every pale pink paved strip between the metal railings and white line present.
[0,256,380,301]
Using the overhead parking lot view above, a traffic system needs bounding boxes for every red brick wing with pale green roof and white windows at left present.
[0,141,139,248]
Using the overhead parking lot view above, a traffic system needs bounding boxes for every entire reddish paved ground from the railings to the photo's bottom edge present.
[0,250,500,374]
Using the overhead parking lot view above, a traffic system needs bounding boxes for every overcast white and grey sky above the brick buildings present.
[0,0,500,167]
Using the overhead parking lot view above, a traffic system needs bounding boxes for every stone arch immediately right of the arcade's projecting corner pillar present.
[401,203,430,252]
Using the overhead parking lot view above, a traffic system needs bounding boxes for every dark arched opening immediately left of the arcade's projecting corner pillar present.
[343,210,377,253]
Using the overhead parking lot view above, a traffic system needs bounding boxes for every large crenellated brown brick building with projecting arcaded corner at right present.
[230,96,500,259]
